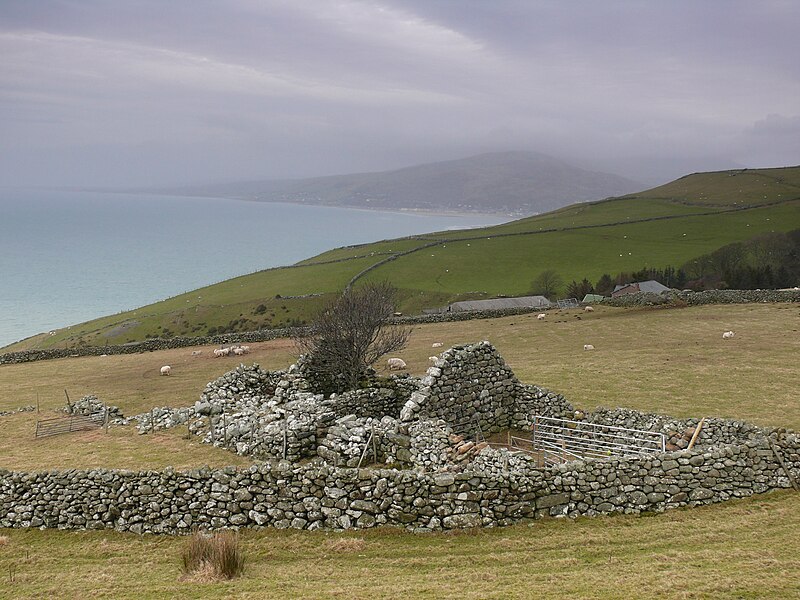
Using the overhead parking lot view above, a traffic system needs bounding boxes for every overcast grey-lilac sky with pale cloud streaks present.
[0,0,800,186]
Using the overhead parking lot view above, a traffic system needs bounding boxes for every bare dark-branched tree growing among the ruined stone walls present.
[295,282,411,391]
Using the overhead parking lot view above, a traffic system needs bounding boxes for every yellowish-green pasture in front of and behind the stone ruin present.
[0,304,800,599]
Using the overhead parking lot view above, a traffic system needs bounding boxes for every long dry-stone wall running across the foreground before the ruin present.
[0,434,800,533]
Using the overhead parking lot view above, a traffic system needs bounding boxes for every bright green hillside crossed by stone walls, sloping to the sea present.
[6,167,800,350]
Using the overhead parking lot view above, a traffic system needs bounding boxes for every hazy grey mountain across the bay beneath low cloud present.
[162,152,644,215]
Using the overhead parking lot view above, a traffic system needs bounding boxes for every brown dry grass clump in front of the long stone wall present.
[181,531,244,582]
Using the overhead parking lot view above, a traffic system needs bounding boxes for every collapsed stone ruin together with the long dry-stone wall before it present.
[0,342,800,533]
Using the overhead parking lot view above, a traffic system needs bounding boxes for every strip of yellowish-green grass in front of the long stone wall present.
[0,492,800,600]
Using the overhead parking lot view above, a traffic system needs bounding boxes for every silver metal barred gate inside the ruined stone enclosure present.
[531,415,666,465]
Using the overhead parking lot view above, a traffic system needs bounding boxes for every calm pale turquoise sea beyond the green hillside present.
[0,189,502,346]
